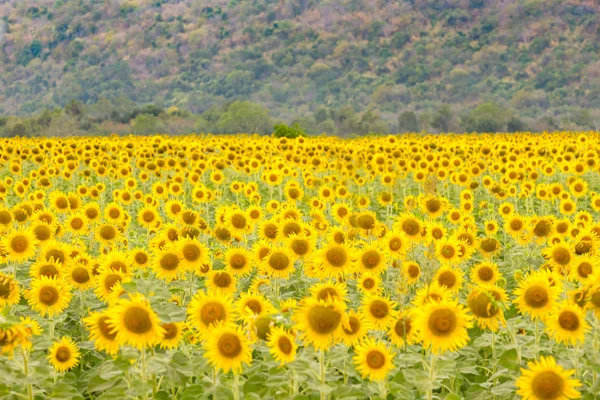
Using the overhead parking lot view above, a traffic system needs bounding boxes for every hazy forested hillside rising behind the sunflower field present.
[0,0,600,133]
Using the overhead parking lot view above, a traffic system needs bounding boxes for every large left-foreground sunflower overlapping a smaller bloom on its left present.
[107,294,165,350]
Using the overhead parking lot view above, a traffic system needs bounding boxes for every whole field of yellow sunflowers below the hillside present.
[0,132,600,400]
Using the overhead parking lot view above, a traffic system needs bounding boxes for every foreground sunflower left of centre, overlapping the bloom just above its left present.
[204,324,252,373]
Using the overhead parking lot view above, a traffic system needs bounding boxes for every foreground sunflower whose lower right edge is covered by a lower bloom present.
[187,291,236,334]
